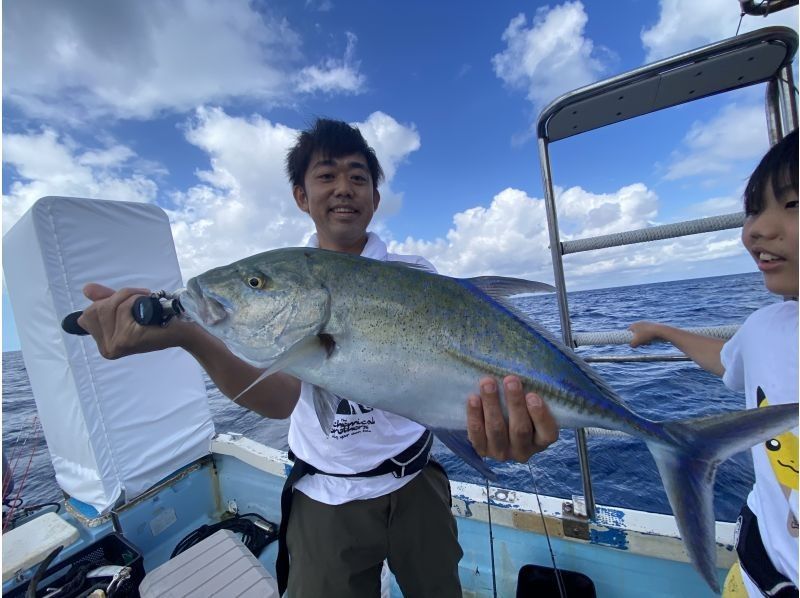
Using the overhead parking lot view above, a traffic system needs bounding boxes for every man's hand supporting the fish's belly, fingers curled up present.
[467,376,558,463]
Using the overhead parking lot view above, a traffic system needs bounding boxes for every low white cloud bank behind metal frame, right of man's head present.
[390,183,748,290]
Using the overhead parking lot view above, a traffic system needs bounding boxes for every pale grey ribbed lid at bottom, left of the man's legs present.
[139,529,279,598]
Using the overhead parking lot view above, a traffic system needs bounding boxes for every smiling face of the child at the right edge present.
[742,185,798,297]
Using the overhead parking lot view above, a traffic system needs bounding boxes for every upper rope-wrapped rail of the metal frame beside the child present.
[561,212,745,255]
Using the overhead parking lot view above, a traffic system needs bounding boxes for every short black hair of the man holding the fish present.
[286,118,383,189]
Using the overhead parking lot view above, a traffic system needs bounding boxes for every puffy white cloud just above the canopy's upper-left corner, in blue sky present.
[492,2,608,108]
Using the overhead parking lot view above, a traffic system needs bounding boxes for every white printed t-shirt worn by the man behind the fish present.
[289,233,438,505]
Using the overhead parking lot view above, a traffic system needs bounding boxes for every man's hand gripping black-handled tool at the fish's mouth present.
[78,283,191,359]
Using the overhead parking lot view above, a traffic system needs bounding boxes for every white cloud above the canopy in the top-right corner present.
[641,0,798,62]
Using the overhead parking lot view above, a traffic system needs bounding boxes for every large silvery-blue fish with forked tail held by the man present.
[179,248,798,592]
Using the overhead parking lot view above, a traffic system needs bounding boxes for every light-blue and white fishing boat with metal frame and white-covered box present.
[2,10,798,598]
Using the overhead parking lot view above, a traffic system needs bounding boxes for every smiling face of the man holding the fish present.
[293,152,380,253]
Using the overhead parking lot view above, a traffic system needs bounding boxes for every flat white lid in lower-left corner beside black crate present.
[3,513,80,582]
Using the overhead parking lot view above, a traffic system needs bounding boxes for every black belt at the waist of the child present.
[736,505,797,598]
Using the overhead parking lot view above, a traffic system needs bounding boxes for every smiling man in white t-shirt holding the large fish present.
[79,119,558,598]
